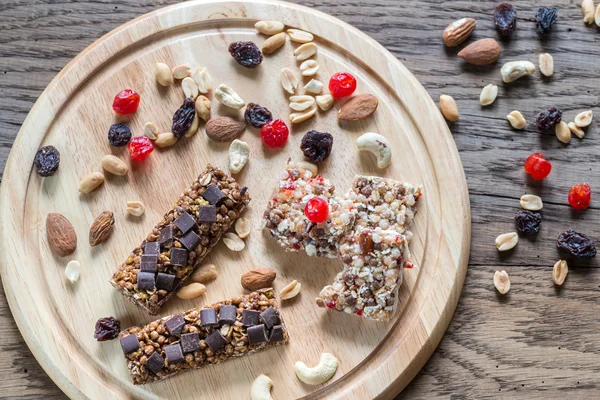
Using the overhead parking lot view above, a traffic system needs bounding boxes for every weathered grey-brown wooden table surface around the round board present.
[0,0,600,399]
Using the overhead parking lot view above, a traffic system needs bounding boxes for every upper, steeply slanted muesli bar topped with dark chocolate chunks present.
[110,165,250,315]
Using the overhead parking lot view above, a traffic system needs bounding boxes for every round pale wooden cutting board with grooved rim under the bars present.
[0,0,470,399]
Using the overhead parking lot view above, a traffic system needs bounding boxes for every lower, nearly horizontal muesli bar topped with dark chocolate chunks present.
[119,288,289,385]
